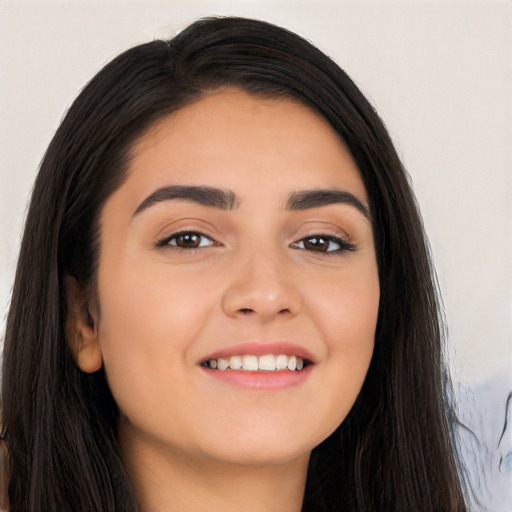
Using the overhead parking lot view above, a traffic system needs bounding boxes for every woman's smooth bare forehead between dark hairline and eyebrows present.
[120,89,366,206]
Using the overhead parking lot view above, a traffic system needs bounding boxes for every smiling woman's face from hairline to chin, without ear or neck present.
[85,89,379,465]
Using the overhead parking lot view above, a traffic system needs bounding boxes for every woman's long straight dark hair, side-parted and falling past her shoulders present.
[2,18,465,512]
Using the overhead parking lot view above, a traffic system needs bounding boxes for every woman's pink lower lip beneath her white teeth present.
[201,365,313,389]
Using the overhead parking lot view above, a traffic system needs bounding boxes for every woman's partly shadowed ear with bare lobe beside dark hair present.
[63,275,103,373]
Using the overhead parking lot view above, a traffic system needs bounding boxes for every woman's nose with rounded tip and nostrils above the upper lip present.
[222,248,303,322]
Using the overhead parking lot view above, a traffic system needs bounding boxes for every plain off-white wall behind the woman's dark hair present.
[0,0,512,512]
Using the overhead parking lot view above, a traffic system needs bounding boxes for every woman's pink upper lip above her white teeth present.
[200,341,315,363]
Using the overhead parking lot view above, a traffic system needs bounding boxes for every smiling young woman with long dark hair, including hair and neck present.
[2,18,465,512]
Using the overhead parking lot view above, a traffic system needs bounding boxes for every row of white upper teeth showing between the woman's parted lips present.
[201,354,311,372]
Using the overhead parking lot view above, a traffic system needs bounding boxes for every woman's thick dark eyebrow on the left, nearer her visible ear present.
[133,185,238,217]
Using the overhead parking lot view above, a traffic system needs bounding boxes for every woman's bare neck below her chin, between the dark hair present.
[120,430,309,512]
